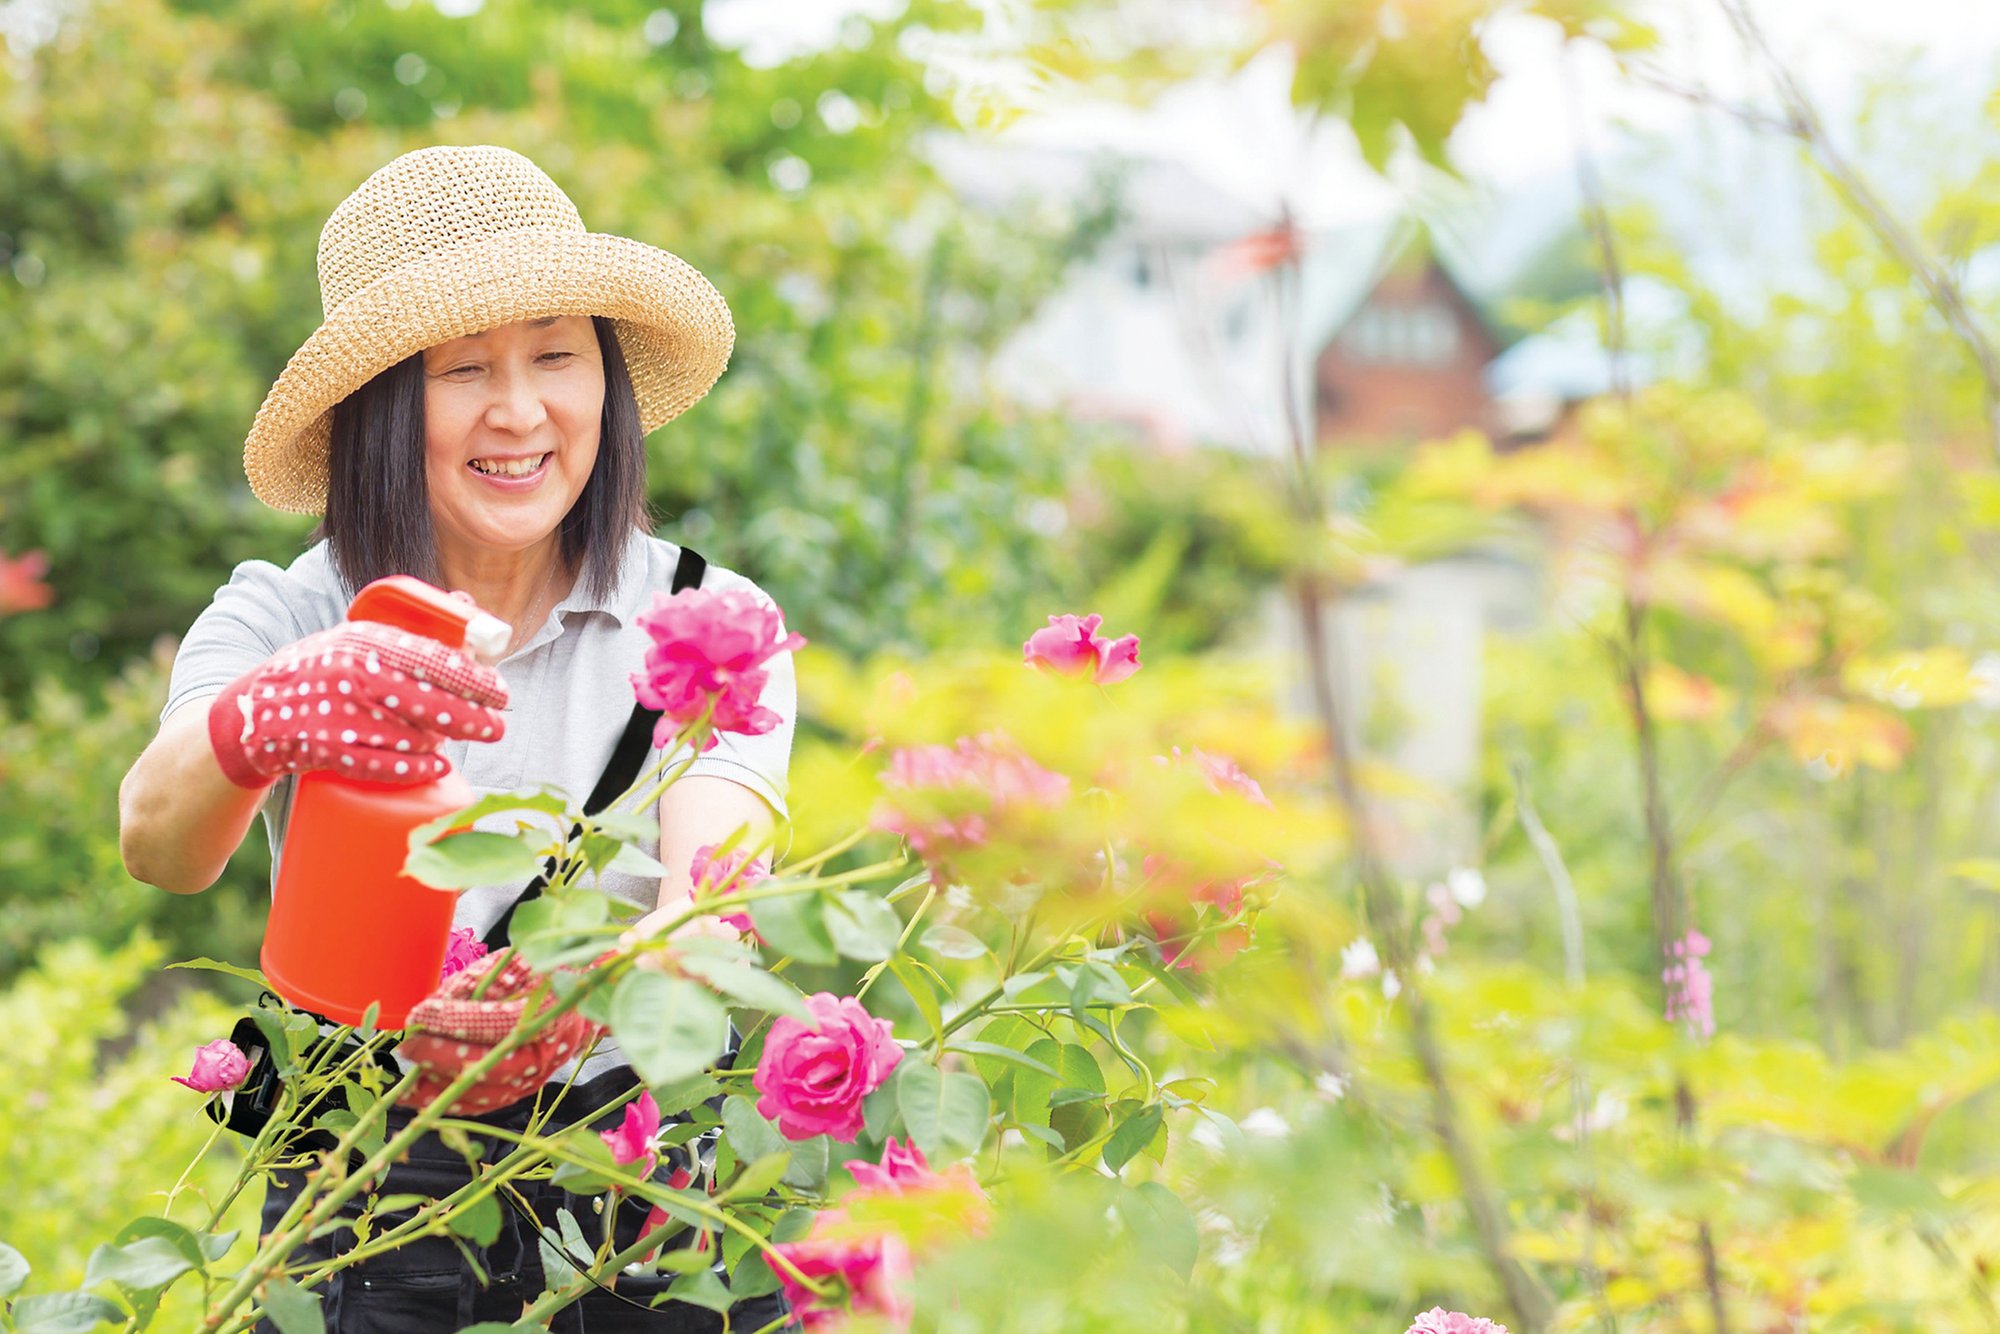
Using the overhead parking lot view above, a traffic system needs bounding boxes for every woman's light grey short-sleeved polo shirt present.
[160,530,798,1078]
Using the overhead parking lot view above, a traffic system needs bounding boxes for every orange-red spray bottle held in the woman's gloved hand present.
[262,574,510,1030]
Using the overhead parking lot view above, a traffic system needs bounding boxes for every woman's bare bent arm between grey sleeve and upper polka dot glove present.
[118,698,270,894]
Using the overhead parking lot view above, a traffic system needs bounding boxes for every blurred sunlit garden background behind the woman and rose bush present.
[0,0,2000,1332]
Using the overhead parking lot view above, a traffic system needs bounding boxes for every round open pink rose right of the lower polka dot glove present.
[750,992,902,1144]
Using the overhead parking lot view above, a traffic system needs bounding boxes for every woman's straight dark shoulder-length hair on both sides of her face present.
[312,316,652,598]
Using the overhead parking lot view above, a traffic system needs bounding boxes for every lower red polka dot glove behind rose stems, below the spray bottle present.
[400,950,604,1116]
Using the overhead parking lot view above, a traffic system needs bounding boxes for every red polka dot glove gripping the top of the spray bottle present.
[208,622,506,788]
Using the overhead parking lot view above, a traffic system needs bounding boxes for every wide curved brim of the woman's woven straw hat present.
[244,230,736,514]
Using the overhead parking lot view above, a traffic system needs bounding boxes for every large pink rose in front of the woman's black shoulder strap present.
[632,588,806,746]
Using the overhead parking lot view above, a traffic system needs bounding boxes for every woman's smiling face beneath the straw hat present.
[424,316,604,558]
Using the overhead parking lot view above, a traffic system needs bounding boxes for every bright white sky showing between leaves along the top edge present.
[708,0,2000,226]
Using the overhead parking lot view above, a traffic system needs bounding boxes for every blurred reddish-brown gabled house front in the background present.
[1314,262,1500,446]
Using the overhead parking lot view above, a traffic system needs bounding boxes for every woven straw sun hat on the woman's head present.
[244,146,736,514]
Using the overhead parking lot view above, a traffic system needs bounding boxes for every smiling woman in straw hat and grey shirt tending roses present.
[120,148,794,1334]
